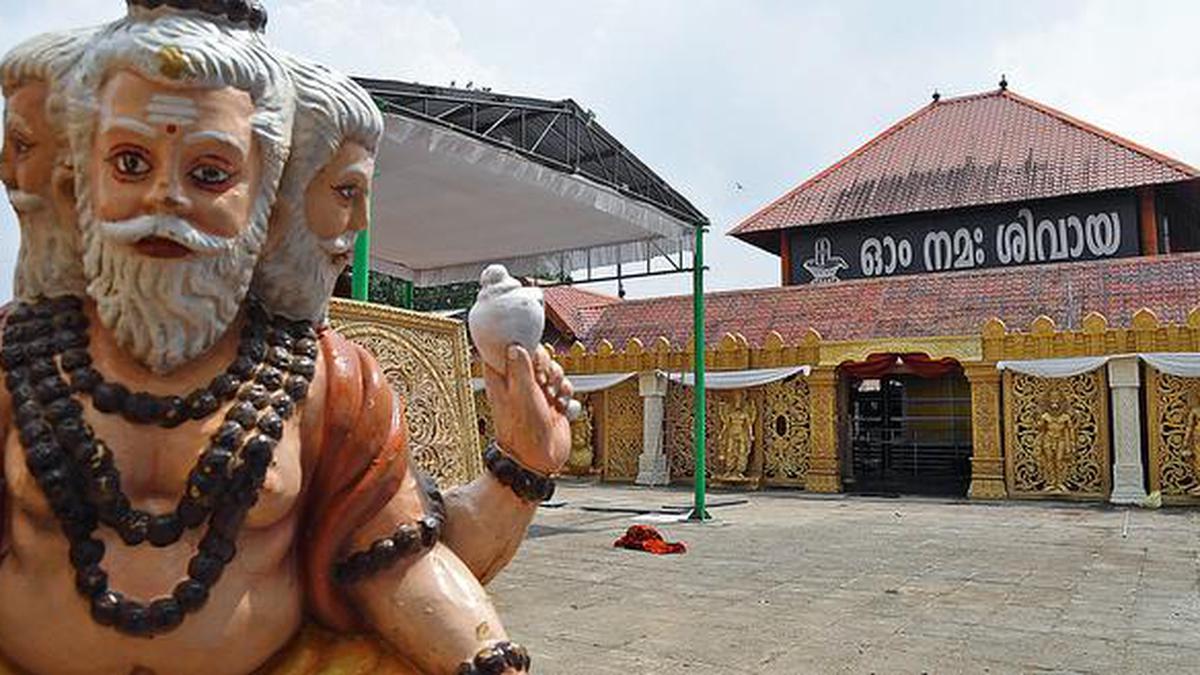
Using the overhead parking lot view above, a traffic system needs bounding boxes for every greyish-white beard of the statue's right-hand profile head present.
[254,214,355,323]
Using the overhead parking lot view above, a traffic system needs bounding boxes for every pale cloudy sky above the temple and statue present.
[0,0,1200,298]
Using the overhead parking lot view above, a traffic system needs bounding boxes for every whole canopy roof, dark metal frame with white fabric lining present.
[359,78,707,286]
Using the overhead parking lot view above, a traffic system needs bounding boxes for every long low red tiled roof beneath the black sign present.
[566,253,1200,348]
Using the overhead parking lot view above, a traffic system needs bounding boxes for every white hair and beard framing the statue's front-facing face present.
[68,12,294,371]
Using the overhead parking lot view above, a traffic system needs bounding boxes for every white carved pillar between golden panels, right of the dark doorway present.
[1109,356,1146,504]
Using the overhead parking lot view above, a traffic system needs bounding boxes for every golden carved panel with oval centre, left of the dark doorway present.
[762,377,812,488]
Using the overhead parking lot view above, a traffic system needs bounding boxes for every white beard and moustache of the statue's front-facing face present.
[84,215,257,372]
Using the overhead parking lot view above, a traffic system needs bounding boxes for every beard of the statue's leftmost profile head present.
[8,191,86,303]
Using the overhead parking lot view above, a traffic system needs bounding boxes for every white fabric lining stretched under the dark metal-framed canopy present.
[371,114,692,286]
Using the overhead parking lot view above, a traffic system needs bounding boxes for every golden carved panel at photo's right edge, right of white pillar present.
[1146,366,1200,503]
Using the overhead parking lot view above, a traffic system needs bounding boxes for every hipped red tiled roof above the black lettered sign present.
[730,89,1200,240]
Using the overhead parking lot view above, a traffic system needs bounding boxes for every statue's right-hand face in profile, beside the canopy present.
[304,142,374,249]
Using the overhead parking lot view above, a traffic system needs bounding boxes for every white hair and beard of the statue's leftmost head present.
[0,28,97,301]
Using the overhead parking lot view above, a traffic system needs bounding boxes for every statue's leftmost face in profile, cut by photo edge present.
[0,80,58,217]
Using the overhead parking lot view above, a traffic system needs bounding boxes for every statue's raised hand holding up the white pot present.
[484,345,572,476]
